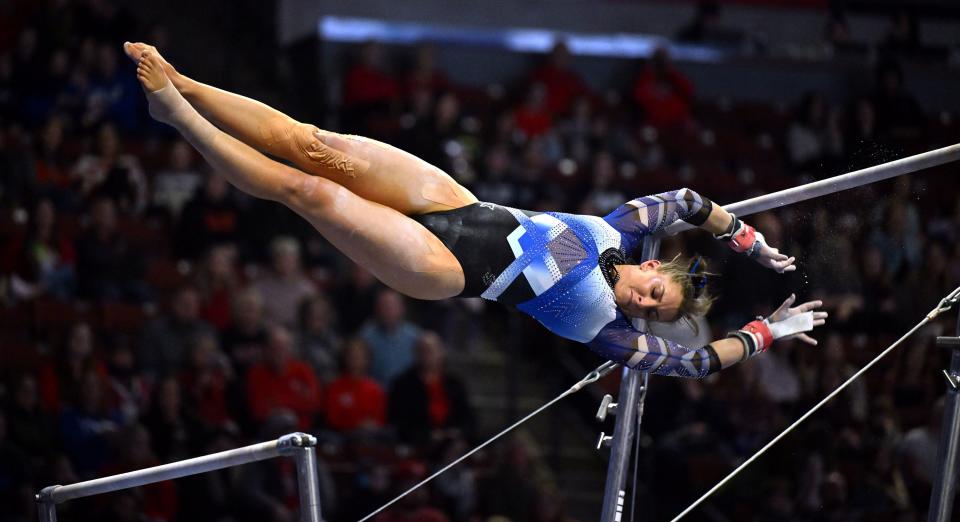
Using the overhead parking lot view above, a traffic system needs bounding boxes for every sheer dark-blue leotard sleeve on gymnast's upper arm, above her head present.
[603,188,713,253]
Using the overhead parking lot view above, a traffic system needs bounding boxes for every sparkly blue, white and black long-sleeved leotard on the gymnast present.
[415,189,720,378]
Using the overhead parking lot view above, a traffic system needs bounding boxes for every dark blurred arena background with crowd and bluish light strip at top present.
[0,0,960,522]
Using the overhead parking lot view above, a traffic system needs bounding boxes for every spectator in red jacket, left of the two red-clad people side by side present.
[247,326,323,431]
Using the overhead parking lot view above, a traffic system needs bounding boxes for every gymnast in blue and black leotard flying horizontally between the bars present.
[124,43,827,378]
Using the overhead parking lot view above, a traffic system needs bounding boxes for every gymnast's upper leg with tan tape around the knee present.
[124,43,477,215]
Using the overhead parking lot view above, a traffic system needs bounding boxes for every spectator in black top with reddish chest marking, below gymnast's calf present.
[176,173,241,259]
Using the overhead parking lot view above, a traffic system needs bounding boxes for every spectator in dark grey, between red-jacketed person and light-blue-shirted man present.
[297,294,342,383]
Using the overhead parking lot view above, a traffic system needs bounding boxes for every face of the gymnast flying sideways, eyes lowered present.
[613,259,683,321]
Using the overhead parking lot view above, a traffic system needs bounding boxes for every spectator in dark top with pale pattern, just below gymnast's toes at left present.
[71,123,147,215]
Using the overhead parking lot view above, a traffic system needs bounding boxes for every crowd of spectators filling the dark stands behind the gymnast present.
[0,0,960,522]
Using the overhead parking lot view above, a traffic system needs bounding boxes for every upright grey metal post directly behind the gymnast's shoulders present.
[600,236,660,522]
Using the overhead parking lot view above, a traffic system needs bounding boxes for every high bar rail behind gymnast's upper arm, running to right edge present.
[664,144,960,235]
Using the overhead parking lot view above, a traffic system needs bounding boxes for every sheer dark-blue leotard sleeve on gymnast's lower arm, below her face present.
[587,314,721,379]
